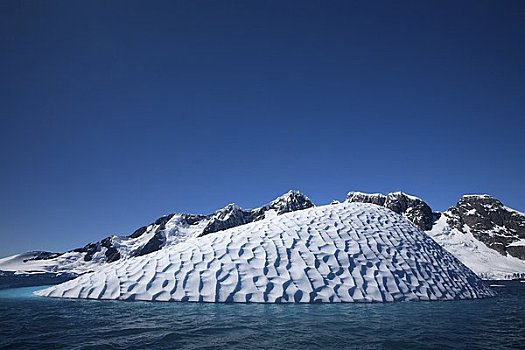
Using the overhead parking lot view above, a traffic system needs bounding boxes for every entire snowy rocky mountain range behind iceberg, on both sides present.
[0,191,525,279]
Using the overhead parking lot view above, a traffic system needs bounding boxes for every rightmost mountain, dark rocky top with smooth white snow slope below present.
[427,195,525,279]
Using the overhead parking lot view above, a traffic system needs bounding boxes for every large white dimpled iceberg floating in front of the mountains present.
[37,203,492,303]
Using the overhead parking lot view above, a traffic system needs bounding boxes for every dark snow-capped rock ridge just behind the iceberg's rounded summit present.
[346,192,435,231]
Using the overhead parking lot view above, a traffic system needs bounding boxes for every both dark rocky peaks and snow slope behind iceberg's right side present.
[347,192,525,279]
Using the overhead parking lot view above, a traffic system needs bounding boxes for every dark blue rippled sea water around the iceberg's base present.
[0,282,525,350]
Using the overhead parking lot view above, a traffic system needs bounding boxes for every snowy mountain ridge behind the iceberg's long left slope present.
[0,191,314,274]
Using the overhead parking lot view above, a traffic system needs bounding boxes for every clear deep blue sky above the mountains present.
[0,0,525,256]
